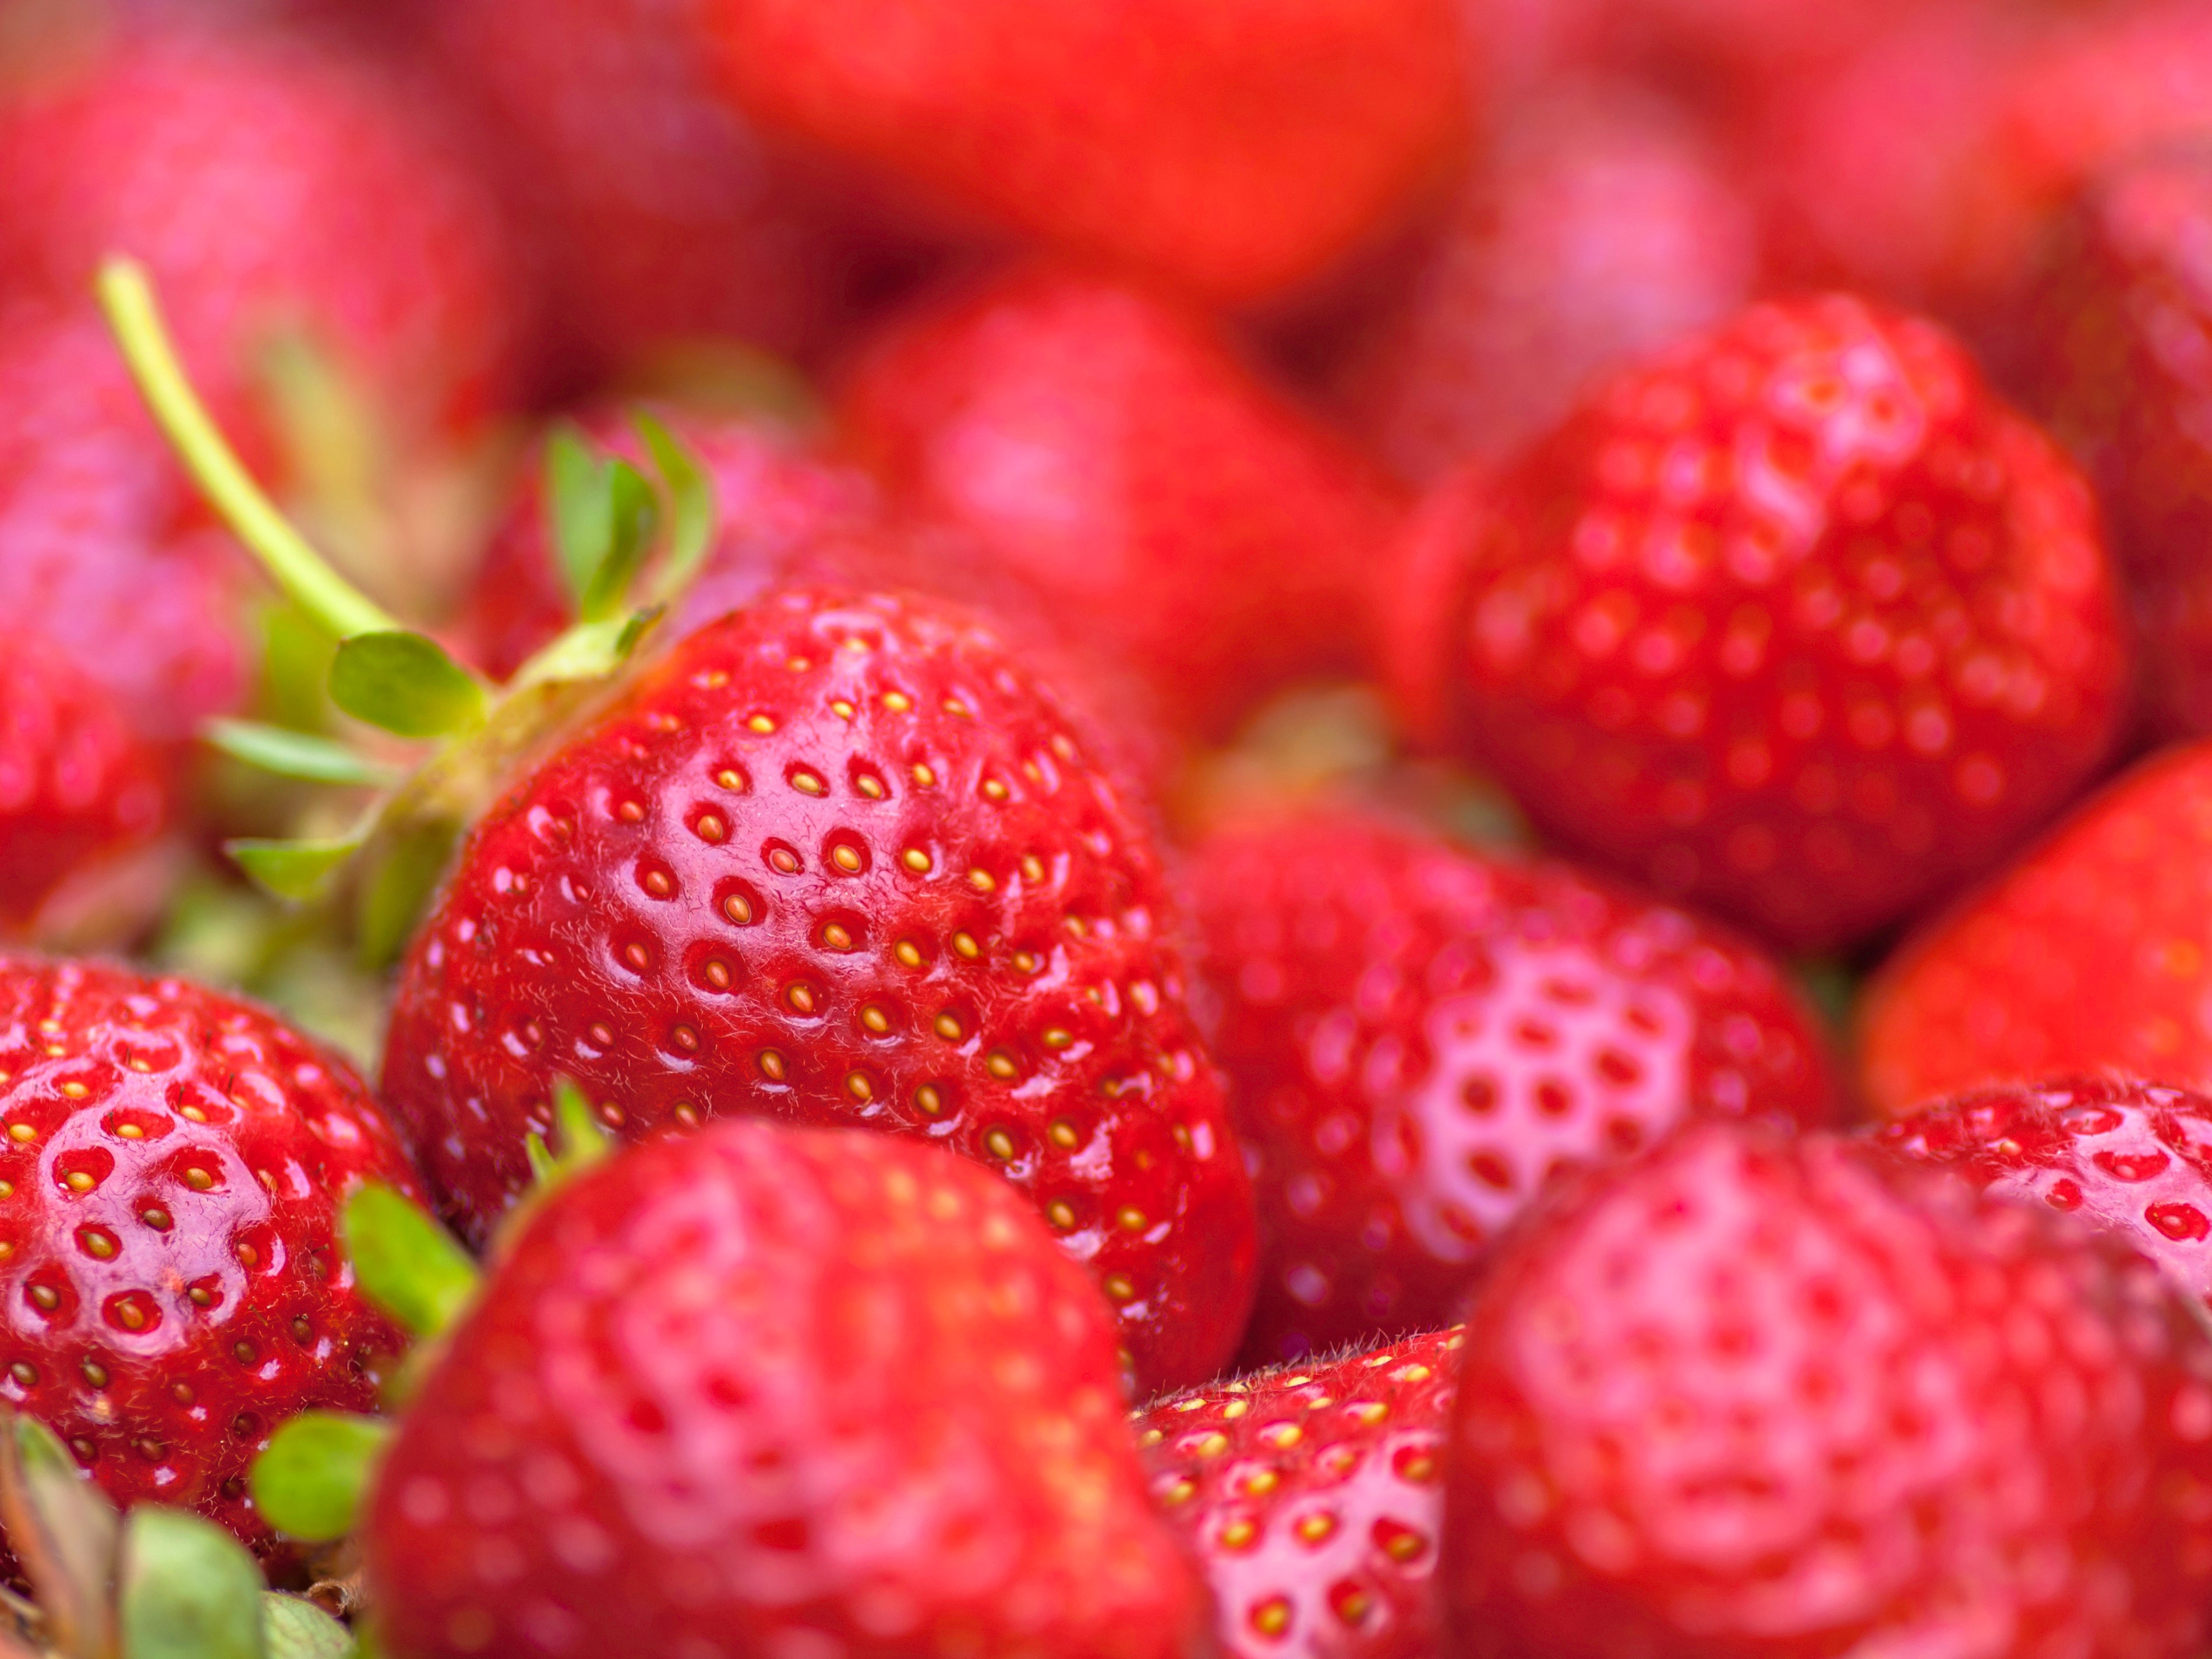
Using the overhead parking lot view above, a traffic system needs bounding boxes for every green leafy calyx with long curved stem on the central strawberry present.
[97,259,715,962]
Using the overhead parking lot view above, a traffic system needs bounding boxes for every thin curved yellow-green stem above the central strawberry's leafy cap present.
[97,259,400,639]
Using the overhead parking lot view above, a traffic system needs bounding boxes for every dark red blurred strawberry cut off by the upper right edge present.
[2015,150,2212,732]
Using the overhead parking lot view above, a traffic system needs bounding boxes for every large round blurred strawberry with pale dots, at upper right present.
[1396,296,2126,947]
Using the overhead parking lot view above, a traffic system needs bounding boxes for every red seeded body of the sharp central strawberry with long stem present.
[383,593,1254,1387]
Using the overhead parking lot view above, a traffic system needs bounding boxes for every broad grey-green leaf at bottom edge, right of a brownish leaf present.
[122,1504,266,1659]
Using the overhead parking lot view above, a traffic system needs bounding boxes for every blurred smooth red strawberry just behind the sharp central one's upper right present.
[840,267,1396,732]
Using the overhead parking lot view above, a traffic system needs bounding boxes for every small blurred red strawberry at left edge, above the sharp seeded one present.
[0,635,170,938]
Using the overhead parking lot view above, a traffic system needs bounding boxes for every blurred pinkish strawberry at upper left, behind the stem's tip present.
[0,20,531,451]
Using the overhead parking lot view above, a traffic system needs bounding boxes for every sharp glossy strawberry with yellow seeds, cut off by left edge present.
[0,955,421,1548]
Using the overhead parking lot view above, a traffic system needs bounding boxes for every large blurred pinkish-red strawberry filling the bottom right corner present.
[1440,1124,2212,1659]
